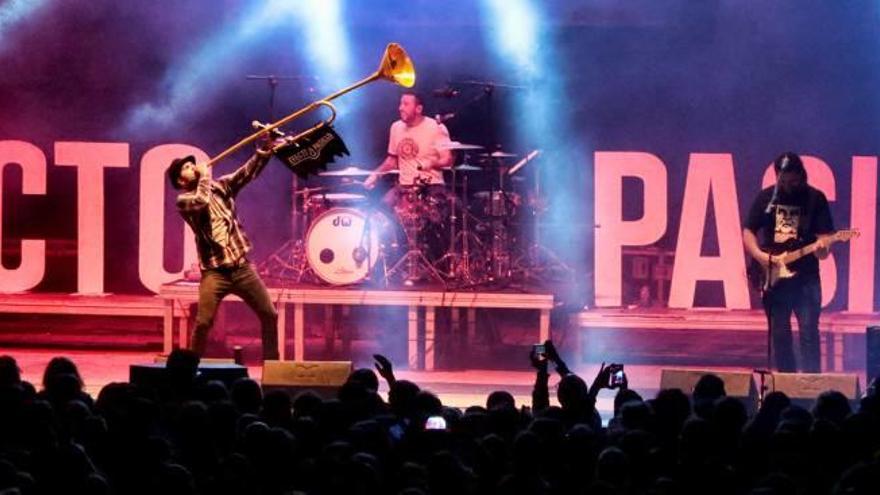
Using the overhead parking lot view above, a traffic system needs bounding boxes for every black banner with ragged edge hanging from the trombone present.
[275,125,349,178]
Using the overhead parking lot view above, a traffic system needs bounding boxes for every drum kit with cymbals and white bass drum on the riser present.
[259,141,572,289]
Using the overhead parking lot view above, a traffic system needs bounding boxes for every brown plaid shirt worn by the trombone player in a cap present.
[177,154,271,270]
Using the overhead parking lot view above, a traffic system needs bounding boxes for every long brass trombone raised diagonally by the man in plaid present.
[205,43,416,167]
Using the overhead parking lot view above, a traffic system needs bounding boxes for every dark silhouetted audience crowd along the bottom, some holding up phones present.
[0,342,880,495]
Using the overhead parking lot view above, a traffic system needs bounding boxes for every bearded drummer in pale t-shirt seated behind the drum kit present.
[364,91,453,203]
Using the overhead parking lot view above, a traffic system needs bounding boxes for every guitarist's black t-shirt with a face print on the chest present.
[745,185,834,275]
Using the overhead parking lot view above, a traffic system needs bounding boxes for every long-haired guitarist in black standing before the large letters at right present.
[743,152,834,373]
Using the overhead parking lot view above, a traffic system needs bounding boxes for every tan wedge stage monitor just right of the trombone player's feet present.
[263,361,352,398]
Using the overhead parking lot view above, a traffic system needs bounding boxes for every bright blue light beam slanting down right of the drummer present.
[482,0,589,280]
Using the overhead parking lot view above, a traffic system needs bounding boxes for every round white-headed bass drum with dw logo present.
[306,208,391,285]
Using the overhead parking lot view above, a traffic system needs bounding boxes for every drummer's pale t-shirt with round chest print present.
[388,117,449,186]
